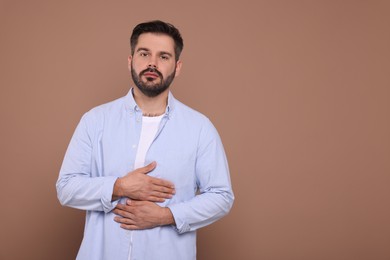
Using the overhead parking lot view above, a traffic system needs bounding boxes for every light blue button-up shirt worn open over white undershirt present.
[56,90,234,260]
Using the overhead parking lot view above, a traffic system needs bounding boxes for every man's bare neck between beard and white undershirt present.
[133,87,169,116]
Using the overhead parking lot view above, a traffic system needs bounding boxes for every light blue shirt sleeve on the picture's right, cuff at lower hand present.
[168,122,234,234]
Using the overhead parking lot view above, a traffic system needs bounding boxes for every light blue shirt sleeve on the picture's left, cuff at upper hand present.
[56,114,118,213]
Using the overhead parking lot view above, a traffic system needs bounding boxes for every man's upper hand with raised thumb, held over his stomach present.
[112,162,175,202]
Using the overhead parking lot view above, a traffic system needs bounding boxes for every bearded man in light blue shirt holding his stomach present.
[56,21,234,260]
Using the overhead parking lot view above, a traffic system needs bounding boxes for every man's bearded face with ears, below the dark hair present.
[128,33,181,97]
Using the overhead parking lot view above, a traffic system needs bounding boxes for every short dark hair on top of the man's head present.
[130,20,184,61]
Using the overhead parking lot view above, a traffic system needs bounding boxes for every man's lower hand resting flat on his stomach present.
[113,200,175,230]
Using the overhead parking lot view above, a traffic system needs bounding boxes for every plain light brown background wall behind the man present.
[0,0,390,260]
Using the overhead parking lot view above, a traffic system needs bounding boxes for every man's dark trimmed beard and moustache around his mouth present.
[131,64,176,97]
